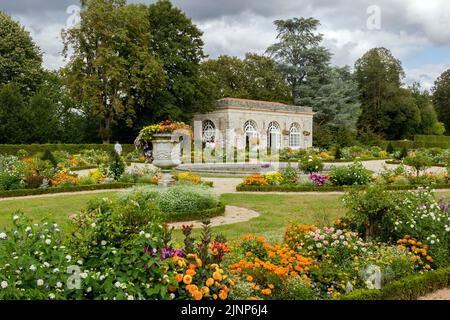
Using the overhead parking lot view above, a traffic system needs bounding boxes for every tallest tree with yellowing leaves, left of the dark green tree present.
[63,0,166,143]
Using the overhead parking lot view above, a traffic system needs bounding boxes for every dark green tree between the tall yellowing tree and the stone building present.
[145,0,212,120]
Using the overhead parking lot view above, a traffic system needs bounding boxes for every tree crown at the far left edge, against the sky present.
[0,11,42,96]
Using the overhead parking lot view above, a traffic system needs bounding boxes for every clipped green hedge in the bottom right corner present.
[337,267,450,300]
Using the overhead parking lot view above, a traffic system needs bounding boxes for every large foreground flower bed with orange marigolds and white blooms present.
[0,185,450,300]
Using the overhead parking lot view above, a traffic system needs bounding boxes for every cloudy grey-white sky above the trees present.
[0,0,450,88]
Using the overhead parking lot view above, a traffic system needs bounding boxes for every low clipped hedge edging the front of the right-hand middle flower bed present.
[236,184,450,192]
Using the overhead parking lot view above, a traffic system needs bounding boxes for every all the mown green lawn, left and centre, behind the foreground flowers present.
[0,191,450,240]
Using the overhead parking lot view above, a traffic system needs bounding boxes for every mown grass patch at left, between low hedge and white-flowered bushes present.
[0,191,117,229]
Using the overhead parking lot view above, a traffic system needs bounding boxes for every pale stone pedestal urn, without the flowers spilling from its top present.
[151,133,181,187]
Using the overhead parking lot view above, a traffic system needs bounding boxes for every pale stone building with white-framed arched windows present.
[193,98,314,150]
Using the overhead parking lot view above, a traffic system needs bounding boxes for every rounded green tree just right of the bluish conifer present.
[355,48,420,139]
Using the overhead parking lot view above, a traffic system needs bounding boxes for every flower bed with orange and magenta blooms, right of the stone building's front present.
[237,155,450,191]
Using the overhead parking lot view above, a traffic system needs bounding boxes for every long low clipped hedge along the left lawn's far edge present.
[0,182,138,198]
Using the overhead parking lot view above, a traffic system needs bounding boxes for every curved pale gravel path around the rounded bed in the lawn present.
[169,206,259,229]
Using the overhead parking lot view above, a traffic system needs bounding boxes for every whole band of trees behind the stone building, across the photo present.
[0,0,450,146]
